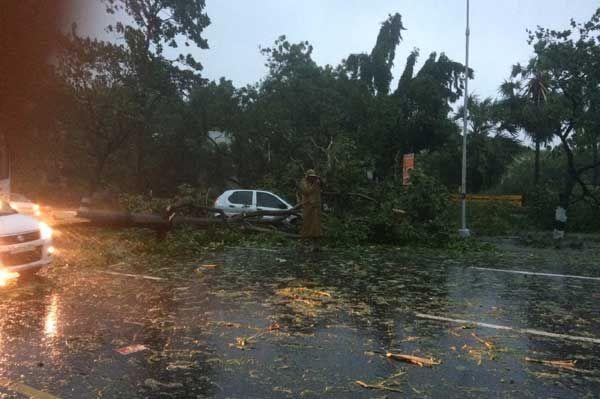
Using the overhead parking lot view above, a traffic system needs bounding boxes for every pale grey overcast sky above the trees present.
[78,0,600,96]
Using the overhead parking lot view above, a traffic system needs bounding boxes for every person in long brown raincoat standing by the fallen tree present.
[300,169,323,251]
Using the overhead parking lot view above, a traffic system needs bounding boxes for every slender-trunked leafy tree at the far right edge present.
[529,9,600,225]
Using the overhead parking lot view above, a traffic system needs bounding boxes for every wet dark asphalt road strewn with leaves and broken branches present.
[0,230,600,398]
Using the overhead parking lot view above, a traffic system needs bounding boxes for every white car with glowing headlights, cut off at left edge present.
[0,200,54,284]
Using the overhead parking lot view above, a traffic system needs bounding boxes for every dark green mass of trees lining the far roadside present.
[8,0,600,234]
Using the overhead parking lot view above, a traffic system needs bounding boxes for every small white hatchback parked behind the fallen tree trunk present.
[215,190,294,219]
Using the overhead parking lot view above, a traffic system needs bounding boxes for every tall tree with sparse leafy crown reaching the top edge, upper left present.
[102,0,210,190]
